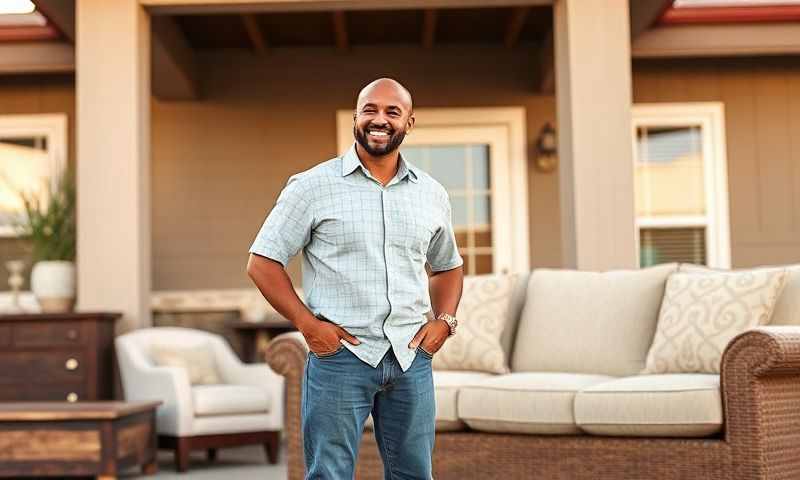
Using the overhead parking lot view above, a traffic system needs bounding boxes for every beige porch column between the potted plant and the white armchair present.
[75,0,151,332]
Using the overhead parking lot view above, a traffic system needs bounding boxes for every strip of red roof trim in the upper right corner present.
[659,5,800,25]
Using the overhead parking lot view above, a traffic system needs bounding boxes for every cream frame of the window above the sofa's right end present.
[631,102,731,268]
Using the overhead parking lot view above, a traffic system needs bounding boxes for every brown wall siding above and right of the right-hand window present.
[634,58,800,267]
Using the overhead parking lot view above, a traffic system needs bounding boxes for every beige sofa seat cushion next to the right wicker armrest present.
[575,373,723,437]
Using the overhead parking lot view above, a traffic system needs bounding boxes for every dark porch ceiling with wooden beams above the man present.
[175,6,552,50]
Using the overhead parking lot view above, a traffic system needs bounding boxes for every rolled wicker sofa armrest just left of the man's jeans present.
[264,332,308,478]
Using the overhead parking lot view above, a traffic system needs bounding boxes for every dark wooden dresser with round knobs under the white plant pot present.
[0,312,121,402]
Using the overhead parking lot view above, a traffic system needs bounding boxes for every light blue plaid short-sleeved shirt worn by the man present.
[250,145,464,371]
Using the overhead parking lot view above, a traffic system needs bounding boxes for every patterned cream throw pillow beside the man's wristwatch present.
[433,273,519,373]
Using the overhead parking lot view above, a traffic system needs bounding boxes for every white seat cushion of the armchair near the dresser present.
[192,384,271,416]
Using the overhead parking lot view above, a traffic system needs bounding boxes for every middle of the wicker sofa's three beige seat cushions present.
[457,372,613,434]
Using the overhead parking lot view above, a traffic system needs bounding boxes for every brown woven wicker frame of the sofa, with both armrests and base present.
[266,327,800,480]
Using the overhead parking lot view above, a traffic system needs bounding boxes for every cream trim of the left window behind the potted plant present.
[0,113,67,237]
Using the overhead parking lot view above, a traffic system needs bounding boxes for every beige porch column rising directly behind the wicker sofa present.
[553,0,638,270]
